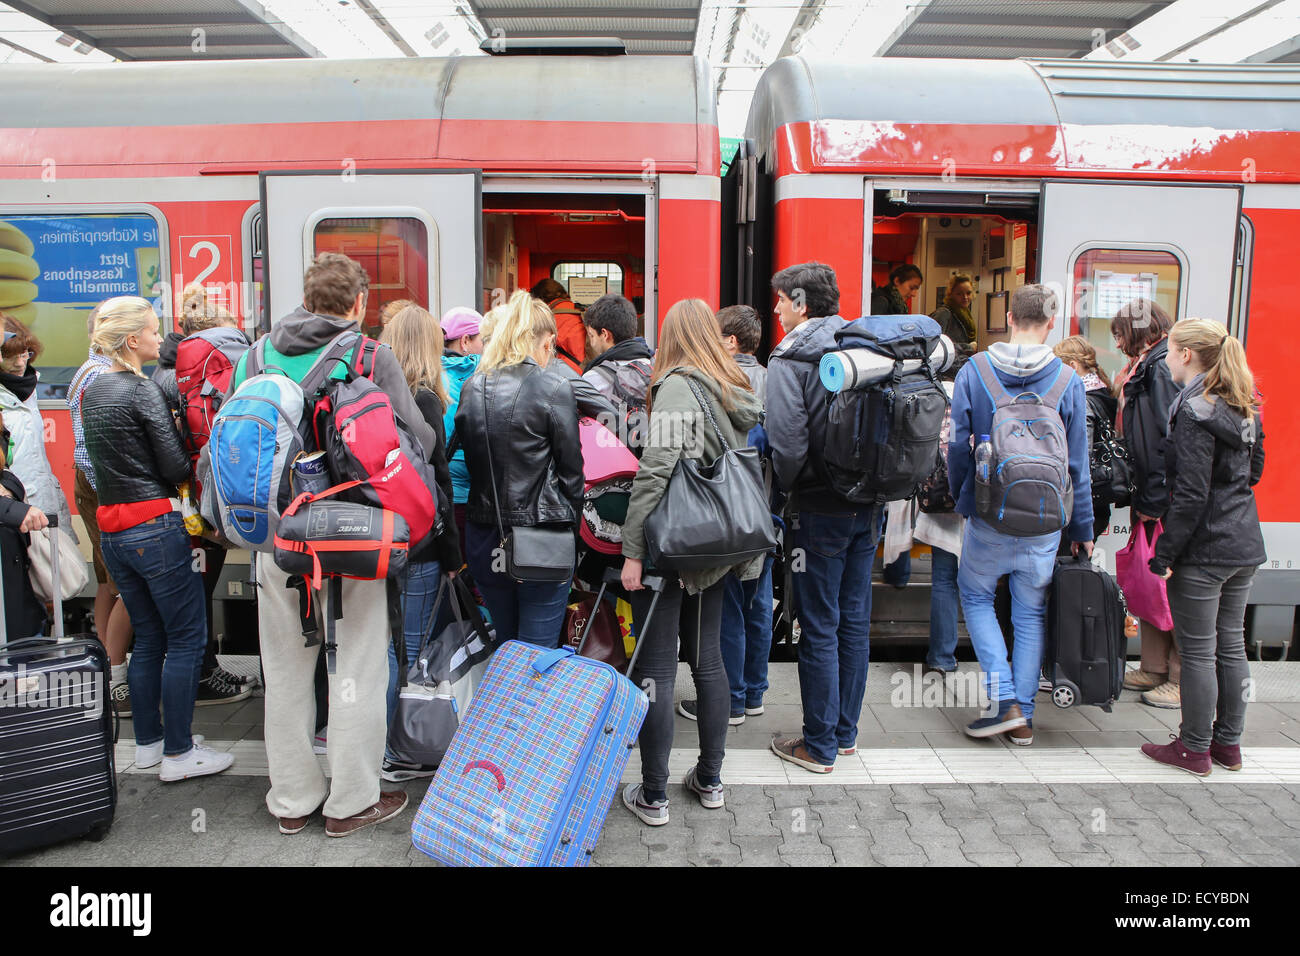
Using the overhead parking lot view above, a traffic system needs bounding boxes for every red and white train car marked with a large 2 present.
[0,56,720,634]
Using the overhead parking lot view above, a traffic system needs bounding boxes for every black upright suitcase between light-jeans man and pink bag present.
[1043,551,1125,711]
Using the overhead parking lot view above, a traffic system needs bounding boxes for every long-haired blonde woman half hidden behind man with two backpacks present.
[380,304,462,780]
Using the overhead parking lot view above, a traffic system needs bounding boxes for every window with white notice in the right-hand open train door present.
[1070,247,1183,375]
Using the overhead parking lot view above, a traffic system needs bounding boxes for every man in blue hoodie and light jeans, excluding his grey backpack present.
[948,285,1092,745]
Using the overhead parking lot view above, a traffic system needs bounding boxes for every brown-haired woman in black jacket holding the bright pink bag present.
[1110,299,1182,710]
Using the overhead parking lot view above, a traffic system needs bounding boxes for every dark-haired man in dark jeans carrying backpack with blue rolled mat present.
[767,263,881,774]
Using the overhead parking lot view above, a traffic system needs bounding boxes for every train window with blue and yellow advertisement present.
[0,212,166,398]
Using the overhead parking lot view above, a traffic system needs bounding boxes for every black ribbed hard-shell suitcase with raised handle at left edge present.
[0,516,117,857]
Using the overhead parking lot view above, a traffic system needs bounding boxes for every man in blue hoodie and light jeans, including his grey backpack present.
[948,285,1092,745]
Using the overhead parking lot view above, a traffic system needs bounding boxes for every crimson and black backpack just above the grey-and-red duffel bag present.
[312,338,438,550]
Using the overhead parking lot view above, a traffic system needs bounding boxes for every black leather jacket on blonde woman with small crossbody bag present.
[456,359,582,528]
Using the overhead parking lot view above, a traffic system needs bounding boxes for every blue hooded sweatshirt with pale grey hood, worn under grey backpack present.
[948,342,1092,541]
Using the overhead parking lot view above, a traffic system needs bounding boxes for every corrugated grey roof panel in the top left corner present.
[7,0,321,60]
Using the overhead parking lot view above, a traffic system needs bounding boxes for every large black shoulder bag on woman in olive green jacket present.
[645,376,776,571]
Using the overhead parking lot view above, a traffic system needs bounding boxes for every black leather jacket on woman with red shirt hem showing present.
[82,372,190,505]
